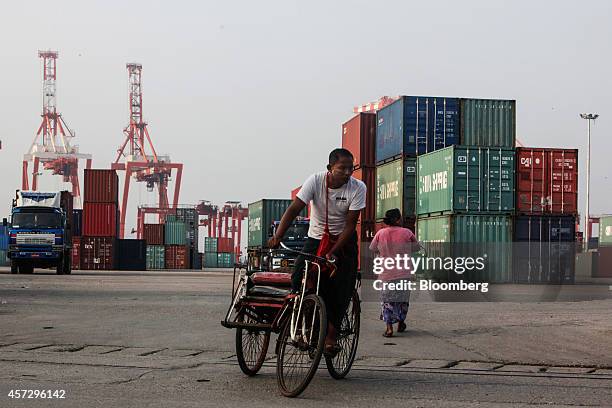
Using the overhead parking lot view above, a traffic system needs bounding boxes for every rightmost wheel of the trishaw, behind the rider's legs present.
[325,291,361,380]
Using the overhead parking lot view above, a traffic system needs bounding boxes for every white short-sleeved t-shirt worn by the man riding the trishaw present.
[297,171,367,239]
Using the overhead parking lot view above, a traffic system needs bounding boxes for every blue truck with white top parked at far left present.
[2,191,73,275]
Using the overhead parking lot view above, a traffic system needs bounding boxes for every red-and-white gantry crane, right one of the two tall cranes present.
[111,63,183,238]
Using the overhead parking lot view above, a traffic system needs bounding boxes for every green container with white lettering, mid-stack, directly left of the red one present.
[417,146,516,217]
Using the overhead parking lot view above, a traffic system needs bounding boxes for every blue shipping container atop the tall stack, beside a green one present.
[376,96,460,163]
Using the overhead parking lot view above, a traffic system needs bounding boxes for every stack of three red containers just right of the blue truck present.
[79,169,119,269]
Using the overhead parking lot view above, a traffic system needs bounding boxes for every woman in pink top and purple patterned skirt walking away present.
[370,208,420,337]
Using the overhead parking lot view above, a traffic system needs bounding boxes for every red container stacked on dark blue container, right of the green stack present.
[513,147,578,284]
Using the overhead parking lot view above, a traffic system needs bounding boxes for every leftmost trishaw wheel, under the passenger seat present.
[236,312,270,376]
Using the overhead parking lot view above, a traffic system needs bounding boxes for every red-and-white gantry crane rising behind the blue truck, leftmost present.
[21,51,91,207]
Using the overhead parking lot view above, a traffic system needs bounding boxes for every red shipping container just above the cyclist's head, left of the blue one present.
[342,113,376,167]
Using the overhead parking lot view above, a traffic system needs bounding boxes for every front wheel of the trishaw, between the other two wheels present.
[276,294,327,397]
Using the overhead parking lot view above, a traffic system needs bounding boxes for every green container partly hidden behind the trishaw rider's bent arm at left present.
[247,199,308,247]
